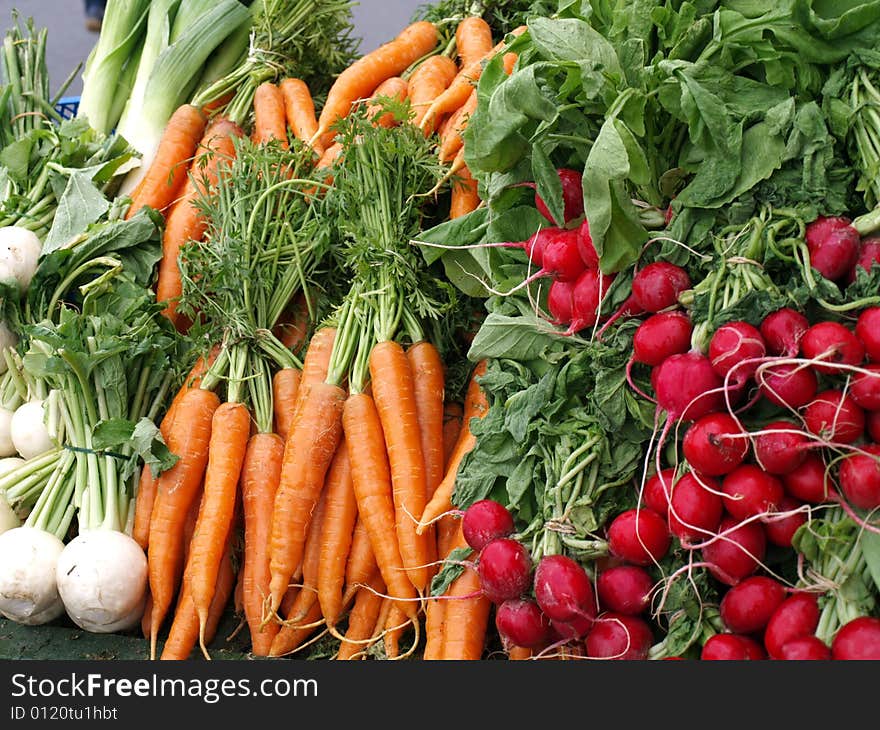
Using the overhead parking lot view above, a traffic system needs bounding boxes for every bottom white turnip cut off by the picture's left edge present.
[0,527,64,626]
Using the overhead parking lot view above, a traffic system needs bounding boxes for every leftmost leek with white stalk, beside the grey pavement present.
[77,0,150,134]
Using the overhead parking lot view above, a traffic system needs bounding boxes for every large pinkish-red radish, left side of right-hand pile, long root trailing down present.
[651,351,723,421]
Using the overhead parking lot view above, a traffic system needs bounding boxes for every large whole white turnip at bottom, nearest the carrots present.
[56,528,147,633]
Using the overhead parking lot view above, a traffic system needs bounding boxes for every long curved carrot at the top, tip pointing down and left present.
[312,20,440,146]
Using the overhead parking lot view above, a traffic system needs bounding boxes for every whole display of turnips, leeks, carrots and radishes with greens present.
[0,0,880,661]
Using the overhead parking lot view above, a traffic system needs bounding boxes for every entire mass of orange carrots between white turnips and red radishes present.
[119,17,524,659]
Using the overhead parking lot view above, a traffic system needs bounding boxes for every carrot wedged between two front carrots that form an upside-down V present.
[317,437,357,628]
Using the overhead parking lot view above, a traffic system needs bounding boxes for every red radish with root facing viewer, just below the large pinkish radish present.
[680,412,749,477]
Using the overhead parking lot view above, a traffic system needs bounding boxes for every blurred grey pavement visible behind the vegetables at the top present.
[0,0,426,96]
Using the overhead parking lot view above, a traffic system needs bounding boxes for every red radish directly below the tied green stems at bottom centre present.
[535,555,596,622]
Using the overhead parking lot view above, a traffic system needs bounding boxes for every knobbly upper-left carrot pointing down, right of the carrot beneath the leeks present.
[156,117,242,326]
